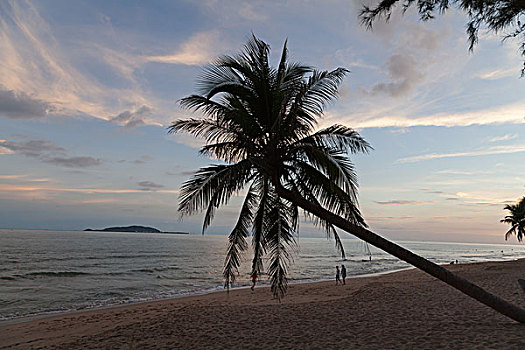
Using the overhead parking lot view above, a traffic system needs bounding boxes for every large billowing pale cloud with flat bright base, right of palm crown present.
[326,13,525,129]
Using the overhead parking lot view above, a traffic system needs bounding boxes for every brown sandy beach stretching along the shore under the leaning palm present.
[0,259,525,349]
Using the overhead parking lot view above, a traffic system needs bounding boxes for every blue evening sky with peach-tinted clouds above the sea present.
[0,0,525,243]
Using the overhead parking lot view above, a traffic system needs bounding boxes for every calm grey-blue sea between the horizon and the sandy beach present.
[0,229,525,321]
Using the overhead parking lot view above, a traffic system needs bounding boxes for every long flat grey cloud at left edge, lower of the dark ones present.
[0,140,102,168]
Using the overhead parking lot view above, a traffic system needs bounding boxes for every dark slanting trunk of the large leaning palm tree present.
[277,185,525,323]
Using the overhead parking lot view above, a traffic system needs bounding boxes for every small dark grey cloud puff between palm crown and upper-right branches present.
[369,54,425,97]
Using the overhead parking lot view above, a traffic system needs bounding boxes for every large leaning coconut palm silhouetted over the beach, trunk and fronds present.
[169,36,525,322]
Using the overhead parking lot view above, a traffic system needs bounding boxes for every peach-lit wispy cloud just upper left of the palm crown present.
[146,31,221,66]
